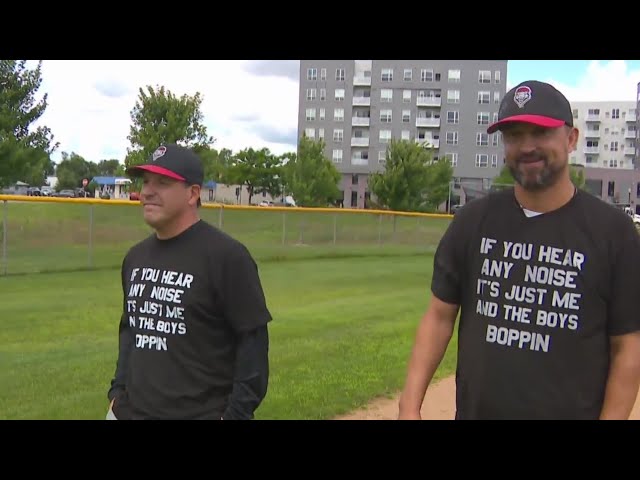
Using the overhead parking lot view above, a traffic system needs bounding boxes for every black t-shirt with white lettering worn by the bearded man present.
[431,189,640,419]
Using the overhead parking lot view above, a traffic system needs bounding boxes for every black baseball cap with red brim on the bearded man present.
[487,80,573,133]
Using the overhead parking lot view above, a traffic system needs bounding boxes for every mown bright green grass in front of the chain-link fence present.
[0,253,456,419]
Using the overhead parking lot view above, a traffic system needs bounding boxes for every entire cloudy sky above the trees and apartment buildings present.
[27,60,640,161]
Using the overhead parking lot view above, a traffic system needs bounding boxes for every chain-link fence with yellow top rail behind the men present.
[0,191,452,276]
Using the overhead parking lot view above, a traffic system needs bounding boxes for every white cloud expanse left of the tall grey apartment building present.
[26,60,298,161]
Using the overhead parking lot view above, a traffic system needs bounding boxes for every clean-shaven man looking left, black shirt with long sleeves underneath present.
[107,144,271,420]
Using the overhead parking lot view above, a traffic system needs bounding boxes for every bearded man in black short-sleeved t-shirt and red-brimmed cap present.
[399,81,640,419]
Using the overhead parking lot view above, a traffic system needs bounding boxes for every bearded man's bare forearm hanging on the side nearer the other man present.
[398,296,458,420]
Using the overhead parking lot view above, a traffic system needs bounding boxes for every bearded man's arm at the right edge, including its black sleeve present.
[600,218,640,420]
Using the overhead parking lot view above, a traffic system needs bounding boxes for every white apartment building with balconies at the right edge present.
[570,101,638,169]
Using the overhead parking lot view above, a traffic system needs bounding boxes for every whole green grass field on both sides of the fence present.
[0,198,456,419]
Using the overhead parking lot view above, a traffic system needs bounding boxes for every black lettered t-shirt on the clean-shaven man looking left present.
[112,221,271,419]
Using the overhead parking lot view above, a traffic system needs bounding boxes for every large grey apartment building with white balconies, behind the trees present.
[298,60,507,208]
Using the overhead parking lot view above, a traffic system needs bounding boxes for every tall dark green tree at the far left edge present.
[0,60,58,186]
